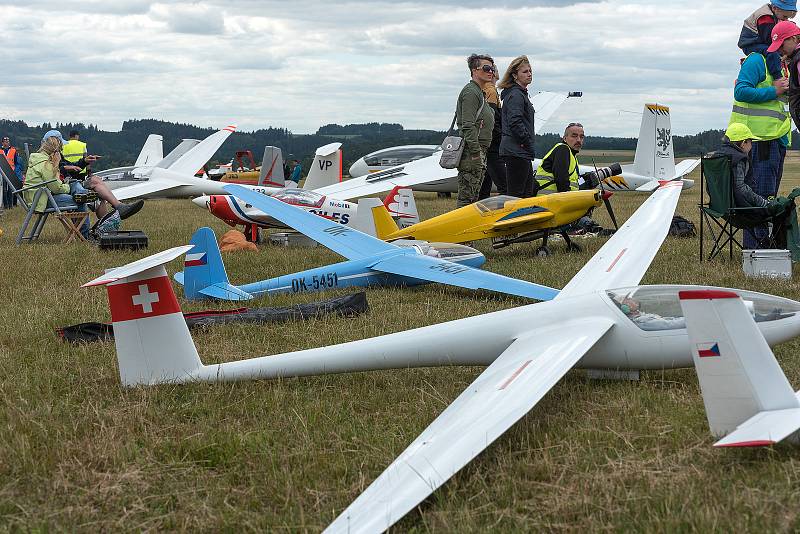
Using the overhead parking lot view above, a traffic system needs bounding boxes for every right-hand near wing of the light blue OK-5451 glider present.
[370,254,558,300]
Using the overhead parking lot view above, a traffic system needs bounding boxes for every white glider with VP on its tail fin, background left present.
[114,134,342,200]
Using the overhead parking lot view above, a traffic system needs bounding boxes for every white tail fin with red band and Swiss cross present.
[84,246,203,386]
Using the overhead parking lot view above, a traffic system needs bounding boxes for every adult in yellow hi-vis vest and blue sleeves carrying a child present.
[728,21,800,248]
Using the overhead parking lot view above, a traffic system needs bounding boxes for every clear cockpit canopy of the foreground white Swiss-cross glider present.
[606,286,800,330]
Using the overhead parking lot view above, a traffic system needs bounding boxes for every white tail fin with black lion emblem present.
[631,104,675,180]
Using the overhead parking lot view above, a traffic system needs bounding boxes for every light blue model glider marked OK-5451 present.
[174,185,558,300]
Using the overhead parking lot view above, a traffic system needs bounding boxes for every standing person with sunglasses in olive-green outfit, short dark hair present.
[456,54,495,208]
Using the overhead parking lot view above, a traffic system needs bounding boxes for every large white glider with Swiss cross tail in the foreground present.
[84,181,800,533]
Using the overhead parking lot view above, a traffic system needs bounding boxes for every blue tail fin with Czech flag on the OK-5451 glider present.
[180,226,252,300]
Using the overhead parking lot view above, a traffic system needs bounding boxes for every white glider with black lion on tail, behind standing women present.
[312,101,700,200]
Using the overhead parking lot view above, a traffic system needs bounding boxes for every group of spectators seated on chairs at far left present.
[2,130,144,239]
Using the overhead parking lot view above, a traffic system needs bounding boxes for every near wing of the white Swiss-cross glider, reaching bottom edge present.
[324,318,613,533]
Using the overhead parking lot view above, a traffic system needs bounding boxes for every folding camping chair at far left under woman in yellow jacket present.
[0,158,89,245]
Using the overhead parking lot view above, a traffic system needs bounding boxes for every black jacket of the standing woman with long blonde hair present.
[500,83,535,160]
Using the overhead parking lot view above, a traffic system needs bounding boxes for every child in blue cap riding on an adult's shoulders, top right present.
[739,0,797,80]
